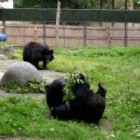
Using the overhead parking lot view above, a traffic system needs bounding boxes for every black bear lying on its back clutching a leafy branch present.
[46,74,106,124]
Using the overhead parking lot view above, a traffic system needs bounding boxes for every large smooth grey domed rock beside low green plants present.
[0,62,42,86]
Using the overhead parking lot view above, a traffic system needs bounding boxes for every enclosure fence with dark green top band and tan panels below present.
[0,8,140,47]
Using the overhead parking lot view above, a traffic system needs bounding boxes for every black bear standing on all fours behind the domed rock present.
[23,42,54,69]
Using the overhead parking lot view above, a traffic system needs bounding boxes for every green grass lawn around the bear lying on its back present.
[0,47,140,140]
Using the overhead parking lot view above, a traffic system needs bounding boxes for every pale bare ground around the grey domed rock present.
[0,58,65,98]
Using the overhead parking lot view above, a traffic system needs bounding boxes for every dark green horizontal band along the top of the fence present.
[0,8,140,23]
